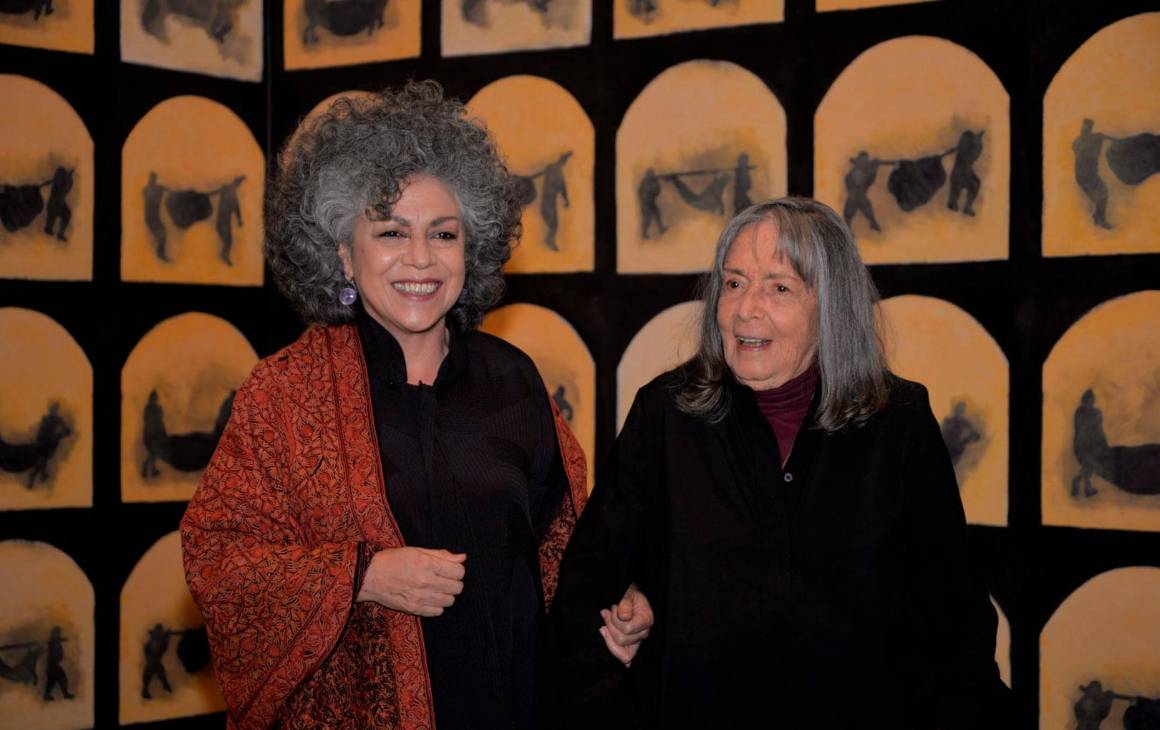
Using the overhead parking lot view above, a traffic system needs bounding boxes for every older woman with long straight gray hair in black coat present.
[549,197,1007,728]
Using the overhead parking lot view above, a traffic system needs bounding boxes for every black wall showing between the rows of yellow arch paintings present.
[0,0,1160,729]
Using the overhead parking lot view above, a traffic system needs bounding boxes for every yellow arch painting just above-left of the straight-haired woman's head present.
[616,60,786,274]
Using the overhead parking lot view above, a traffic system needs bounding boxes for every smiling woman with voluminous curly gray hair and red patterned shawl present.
[182,82,651,730]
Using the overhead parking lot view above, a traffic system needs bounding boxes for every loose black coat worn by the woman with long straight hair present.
[549,371,1008,728]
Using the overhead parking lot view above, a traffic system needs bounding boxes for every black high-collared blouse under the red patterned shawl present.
[357,311,568,730]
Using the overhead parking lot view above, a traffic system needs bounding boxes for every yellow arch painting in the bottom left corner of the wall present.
[0,540,94,730]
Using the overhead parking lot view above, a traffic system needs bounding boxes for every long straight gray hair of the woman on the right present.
[676,197,886,432]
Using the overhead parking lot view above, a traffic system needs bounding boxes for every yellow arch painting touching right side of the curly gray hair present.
[467,75,596,274]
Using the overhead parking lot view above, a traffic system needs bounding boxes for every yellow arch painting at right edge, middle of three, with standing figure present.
[1042,290,1160,530]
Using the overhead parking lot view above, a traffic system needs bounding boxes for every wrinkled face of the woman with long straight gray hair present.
[717,219,818,390]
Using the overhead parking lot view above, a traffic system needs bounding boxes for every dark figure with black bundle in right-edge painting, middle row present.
[1072,389,1160,497]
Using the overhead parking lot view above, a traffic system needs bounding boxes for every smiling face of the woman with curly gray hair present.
[339,175,465,344]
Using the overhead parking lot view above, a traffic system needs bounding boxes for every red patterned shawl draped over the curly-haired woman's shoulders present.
[181,325,587,730]
